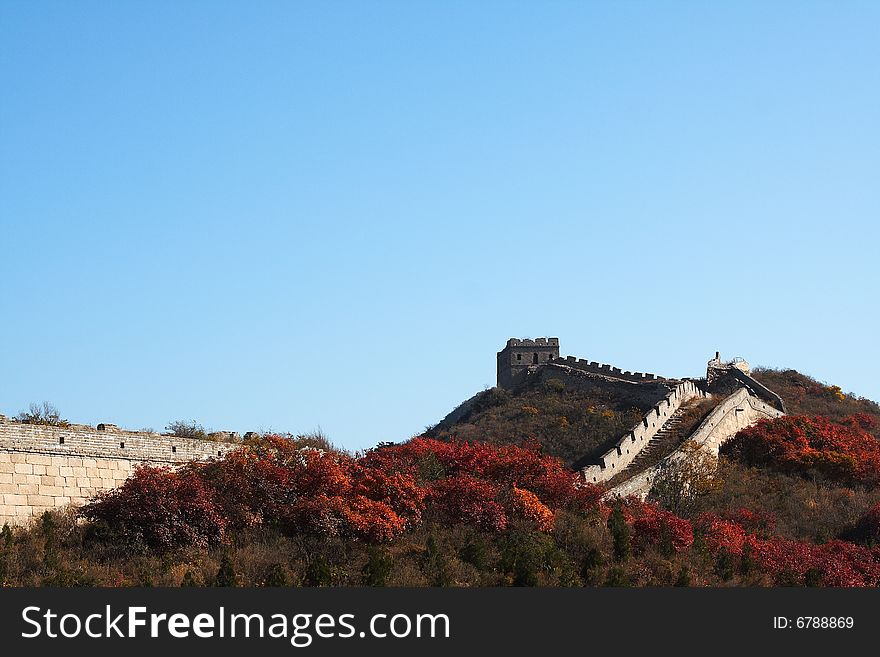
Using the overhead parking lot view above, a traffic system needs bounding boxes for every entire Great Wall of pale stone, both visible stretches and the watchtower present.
[0,338,785,526]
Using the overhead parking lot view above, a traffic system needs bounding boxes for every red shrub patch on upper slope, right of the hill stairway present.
[721,414,880,486]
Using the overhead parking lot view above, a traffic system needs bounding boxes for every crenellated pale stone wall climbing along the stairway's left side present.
[581,381,706,483]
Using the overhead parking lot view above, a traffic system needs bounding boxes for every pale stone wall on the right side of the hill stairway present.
[604,388,784,499]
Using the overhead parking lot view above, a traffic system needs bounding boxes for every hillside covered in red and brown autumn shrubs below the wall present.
[0,370,880,587]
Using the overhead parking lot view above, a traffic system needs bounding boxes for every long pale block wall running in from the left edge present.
[0,415,227,526]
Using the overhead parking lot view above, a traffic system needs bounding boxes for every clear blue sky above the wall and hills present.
[0,0,880,449]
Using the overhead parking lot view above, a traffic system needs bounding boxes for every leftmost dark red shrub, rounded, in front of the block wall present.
[80,466,226,551]
